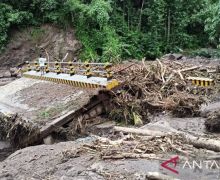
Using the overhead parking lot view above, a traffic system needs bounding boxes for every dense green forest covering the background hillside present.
[0,0,220,61]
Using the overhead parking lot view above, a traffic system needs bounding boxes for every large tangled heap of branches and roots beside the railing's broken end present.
[110,60,207,124]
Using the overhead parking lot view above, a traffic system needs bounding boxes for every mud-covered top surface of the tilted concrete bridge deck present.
[0,78,102,144]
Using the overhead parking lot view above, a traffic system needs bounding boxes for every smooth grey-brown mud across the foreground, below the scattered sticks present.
[0,137,219,180]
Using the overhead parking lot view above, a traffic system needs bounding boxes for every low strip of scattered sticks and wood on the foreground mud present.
[83,134,199,159]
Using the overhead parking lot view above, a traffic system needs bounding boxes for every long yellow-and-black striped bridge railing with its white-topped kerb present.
[23,61,119,90]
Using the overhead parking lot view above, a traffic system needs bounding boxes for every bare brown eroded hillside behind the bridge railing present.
[0,25,80,68]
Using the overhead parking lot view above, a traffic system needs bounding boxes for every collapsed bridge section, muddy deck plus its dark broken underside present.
[0,77,113,147]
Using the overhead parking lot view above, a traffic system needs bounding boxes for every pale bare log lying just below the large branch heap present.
[113,126,166,136]
